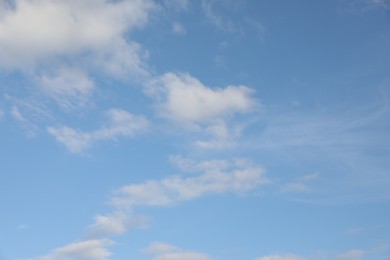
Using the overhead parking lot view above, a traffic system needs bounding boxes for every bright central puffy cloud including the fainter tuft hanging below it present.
[145,73,260,149]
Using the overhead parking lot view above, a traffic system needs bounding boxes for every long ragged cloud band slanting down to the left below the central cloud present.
[89,156,269,237]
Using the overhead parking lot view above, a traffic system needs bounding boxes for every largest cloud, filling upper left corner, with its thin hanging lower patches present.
[0,0,156,110]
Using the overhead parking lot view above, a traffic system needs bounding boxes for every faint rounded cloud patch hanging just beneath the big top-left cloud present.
[38,68,95,109]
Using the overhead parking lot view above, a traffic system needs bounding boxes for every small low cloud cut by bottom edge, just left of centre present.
[144,242,211,260]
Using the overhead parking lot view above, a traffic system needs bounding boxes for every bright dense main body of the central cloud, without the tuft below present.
[147,73,258,123]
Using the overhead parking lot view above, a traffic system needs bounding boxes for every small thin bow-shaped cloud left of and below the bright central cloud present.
[47,109,149,153]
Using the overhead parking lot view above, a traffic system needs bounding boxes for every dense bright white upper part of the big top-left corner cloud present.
[0,0,154,68]
